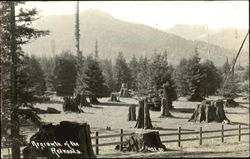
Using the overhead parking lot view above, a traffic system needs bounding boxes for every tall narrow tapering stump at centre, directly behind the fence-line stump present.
[135,98,153,129]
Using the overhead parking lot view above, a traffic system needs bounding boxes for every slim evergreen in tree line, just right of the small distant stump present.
[129,55,138,90]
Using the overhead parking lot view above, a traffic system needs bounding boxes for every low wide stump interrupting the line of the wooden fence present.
[116,131,167,152]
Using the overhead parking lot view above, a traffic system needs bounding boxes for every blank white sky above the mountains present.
[20,1,249,29]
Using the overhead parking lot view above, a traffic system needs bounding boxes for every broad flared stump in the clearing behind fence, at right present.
[188,100,230,123]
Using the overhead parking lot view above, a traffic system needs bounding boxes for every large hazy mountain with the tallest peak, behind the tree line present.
[24,9,248,65]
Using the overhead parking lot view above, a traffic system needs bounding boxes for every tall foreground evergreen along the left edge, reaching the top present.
[0,2,48,158]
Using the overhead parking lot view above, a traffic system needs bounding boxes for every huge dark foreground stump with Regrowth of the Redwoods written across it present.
[23,121,95,159]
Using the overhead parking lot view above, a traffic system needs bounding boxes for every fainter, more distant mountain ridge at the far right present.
[165,24,249,52]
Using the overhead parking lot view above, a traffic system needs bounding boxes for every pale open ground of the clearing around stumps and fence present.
[1,96,249,158]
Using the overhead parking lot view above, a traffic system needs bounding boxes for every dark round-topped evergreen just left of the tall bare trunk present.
[54,52,77,96]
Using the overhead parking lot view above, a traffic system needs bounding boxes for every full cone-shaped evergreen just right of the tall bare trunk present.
[75,56,107,104]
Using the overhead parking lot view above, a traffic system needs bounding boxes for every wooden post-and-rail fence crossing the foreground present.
[91,125,249,155]
